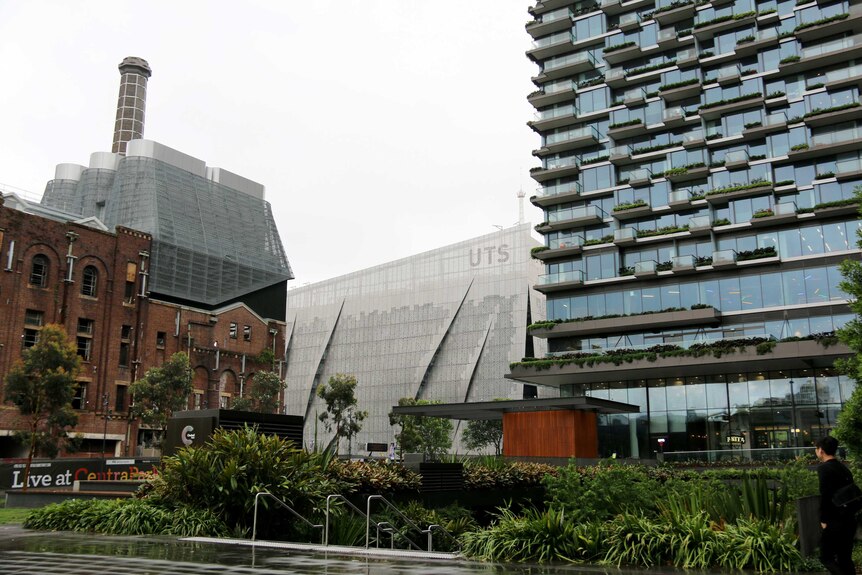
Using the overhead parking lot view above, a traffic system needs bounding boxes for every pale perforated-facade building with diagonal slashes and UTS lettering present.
[285,225,545,451]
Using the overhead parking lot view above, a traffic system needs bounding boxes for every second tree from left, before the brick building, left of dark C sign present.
[129,352,192,444]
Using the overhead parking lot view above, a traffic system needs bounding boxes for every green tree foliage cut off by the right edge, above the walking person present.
[833,187,862,458]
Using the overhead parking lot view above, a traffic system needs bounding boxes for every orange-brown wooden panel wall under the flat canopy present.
[503,410,598,458]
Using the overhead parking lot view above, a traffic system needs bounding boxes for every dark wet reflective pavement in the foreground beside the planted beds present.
[0,525,656,575]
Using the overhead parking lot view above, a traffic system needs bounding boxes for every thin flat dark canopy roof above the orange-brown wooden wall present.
[392,396,640,419]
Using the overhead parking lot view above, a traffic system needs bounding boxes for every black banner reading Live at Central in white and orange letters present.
[0,457,159,491]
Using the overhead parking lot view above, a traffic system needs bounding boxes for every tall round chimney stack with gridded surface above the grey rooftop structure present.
[111,56,153,154]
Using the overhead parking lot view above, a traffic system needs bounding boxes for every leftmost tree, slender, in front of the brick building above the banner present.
[6,324,81,490]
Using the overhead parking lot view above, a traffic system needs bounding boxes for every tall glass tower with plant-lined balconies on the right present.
[509,0,862,457]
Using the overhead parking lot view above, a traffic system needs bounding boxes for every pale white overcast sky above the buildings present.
[0,0,541,286]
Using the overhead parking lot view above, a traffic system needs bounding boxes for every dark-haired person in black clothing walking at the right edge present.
[814,436,856,575]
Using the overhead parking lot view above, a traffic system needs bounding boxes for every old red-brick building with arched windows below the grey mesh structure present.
[0,195,284,457]
